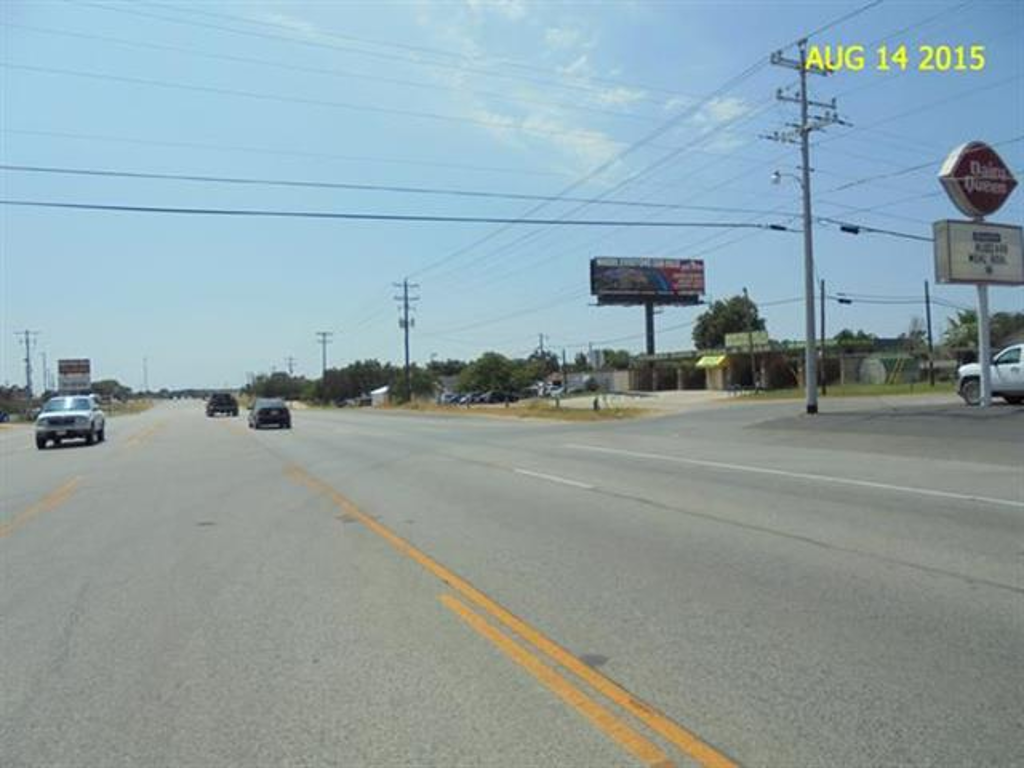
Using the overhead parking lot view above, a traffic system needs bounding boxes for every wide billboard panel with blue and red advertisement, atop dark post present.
[590,257,705,304]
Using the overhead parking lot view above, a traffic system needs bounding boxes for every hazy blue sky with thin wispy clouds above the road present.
[0,0,1024,389]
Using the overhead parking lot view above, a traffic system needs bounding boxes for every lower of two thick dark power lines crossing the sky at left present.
[0,200,785,231]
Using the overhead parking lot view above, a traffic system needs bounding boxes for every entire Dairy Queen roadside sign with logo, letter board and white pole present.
[933,141,1024,408]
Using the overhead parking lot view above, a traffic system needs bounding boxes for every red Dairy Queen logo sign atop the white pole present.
[939,141,1017,218]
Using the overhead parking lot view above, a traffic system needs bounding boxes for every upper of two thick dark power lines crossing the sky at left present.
[0,164,802,218]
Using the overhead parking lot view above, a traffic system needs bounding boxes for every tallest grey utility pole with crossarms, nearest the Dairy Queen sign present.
[767,38,849,414]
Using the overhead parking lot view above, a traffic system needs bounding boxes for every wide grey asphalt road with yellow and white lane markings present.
[0,401,1024,768]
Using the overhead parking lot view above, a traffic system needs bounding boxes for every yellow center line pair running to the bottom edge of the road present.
[286,466,736,768]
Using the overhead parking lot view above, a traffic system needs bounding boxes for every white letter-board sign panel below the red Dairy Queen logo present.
[933,220,1024,286]
